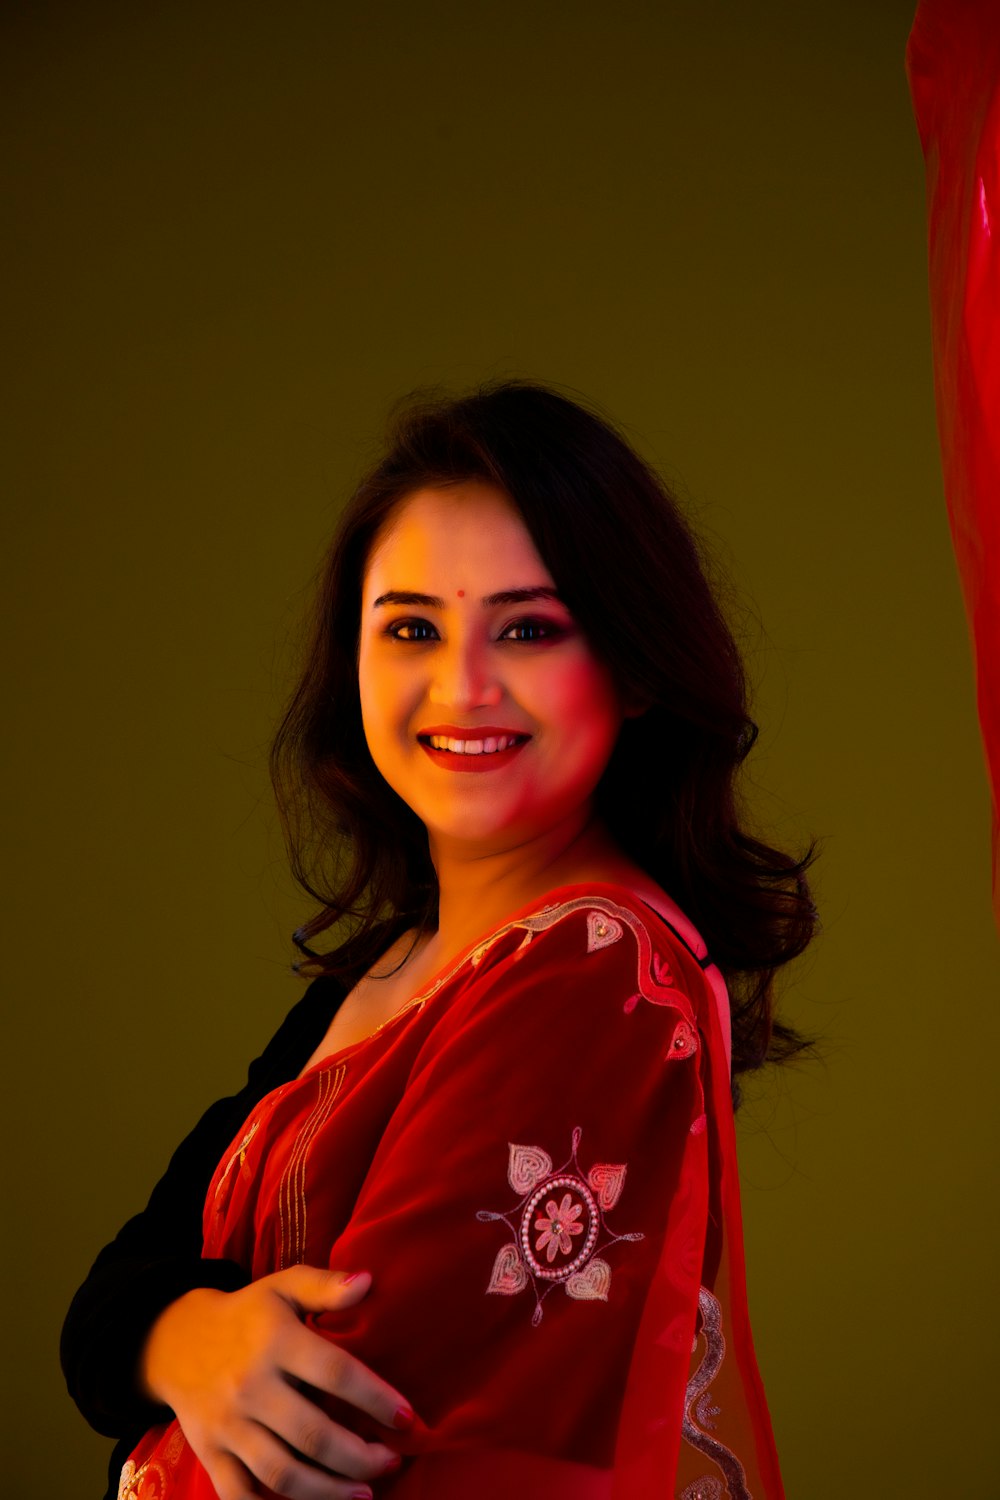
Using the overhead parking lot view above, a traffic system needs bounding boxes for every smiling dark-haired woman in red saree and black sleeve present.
[63,381,816,1500]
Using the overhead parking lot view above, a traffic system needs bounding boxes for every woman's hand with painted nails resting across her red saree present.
[139,1266,412,1500]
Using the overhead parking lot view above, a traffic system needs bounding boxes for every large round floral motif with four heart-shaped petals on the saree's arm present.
[475,1127,645,1328]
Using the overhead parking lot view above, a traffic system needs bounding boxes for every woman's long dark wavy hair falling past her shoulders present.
[271,380,819,1098]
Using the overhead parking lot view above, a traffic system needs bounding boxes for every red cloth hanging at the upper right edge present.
[906,0,1000,926]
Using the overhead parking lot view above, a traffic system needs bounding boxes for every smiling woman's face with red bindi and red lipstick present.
[358,480,624,854]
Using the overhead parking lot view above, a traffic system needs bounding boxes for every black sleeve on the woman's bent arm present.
[60,978,343,1446]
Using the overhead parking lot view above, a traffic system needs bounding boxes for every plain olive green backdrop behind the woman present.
[0,0,1000,1500]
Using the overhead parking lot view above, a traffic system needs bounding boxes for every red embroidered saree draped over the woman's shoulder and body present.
[120,885,783,1500]
